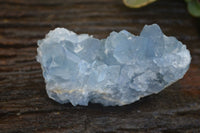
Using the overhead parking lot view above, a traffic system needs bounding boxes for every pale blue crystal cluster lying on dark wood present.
[37,24,191,106]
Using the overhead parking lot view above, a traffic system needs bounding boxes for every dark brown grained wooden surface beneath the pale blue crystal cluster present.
[0,0,200,133]
